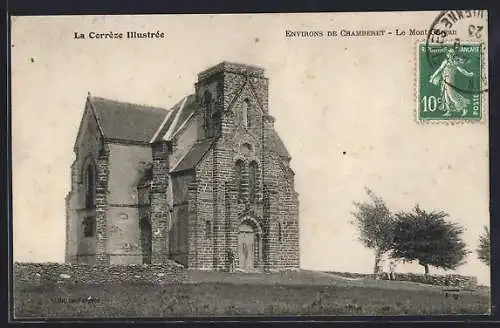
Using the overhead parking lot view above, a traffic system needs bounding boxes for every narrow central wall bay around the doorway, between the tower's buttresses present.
[219,106,265,270]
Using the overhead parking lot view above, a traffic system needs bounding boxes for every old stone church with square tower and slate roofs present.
[66,62,299,271]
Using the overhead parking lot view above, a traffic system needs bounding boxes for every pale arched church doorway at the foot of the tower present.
[238,219,262,272]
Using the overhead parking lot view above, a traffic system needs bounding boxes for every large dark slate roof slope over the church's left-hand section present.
[89,96,168,142]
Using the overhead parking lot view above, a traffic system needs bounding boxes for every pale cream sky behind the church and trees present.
[11,12,490,284]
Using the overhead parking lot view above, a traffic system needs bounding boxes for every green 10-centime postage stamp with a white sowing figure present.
[417,43,483,121]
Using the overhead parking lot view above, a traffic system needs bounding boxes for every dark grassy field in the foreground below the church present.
[14,271,489,318]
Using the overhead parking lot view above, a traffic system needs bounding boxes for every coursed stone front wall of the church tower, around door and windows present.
[189,63,299,270]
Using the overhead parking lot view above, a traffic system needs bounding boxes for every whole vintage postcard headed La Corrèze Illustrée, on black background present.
[10,10,490,320]
